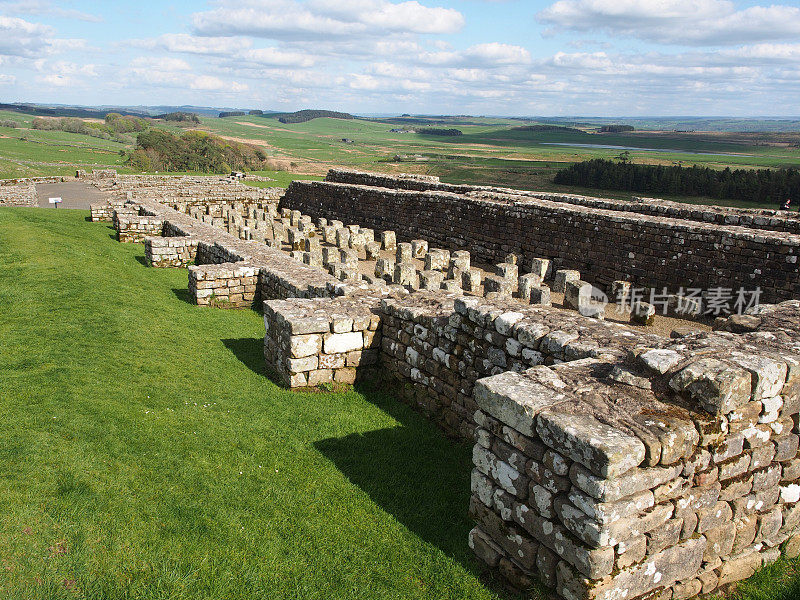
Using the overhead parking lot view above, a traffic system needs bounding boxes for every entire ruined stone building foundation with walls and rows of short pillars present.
[81,166,800,600]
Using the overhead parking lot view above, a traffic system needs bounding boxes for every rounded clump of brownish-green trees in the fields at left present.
[128,129,267,173]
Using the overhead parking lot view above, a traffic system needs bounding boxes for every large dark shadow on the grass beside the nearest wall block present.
[314,381,536,599]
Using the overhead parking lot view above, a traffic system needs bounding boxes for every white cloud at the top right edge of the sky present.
[537,0,800,46]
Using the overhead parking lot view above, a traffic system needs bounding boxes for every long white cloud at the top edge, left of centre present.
[193,0,464,39]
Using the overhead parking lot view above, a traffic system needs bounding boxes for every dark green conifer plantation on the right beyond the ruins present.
[553,158,800,204]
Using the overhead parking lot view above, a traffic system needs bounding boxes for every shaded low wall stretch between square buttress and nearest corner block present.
[381,292,663,440]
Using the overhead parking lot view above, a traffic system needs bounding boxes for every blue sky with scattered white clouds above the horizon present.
[0,0,800,117]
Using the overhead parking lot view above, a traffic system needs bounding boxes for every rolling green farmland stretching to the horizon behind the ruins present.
[0,111,800,208]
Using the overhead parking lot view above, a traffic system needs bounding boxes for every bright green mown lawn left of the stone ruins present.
[0,208,520,600]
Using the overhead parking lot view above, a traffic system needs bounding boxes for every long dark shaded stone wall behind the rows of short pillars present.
[281,176,800,302]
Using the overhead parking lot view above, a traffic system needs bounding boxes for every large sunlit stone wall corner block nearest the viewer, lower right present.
[470,310,800,600]
